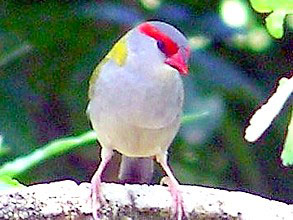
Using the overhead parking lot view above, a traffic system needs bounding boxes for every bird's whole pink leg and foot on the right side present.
[156,153,187,220]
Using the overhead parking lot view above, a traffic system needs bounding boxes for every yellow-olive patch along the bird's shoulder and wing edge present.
[89,37,127,99]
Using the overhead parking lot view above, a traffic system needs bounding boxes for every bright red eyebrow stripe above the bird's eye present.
[138,23,179,57]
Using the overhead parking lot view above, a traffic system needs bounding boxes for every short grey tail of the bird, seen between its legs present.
[119,155,154,184]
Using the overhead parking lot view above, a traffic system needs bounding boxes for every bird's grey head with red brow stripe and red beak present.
[128,21,190,75]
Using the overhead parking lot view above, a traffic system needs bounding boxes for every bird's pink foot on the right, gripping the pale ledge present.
[160,176,188,220]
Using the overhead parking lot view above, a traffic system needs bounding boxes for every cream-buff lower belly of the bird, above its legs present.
[90,105,180,157]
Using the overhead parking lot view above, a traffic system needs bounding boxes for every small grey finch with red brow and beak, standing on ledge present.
[87,21,190,219]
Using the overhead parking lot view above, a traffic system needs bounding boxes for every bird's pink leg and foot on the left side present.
[91,147,113,220]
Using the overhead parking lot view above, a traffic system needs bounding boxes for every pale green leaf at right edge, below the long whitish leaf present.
[281,109,293,166]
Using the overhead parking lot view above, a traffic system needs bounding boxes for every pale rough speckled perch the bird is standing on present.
[0,180,293,220]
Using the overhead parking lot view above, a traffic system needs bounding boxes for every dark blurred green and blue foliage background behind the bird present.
[0,0,293,205]
